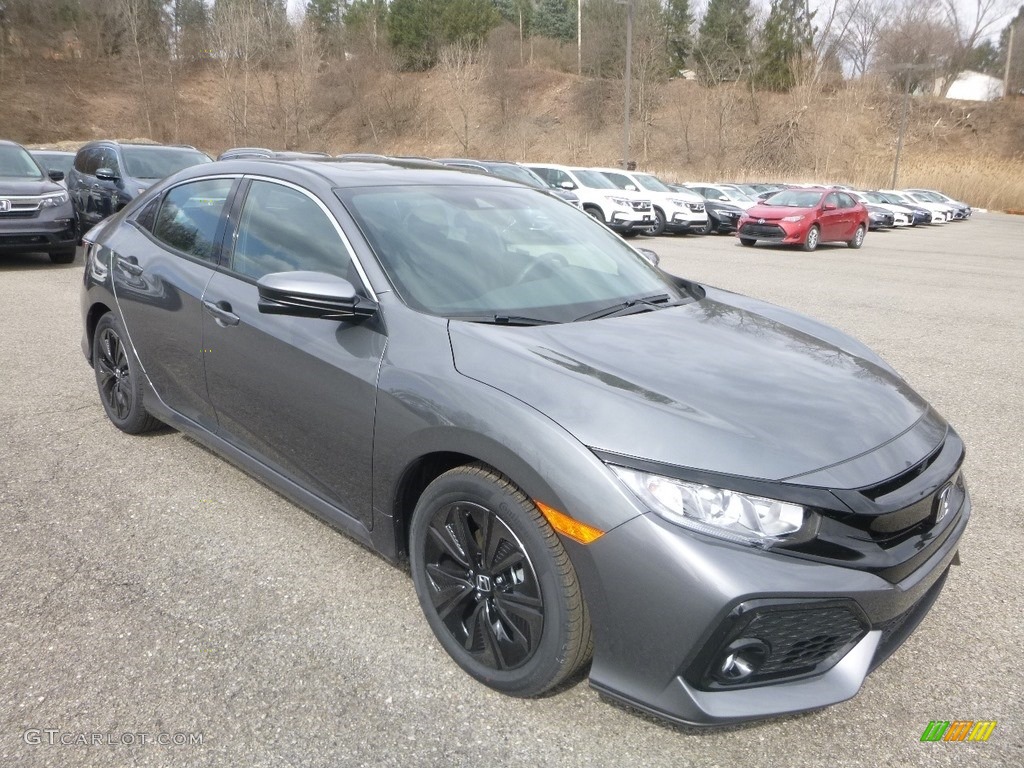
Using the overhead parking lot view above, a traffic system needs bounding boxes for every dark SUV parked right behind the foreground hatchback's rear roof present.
[68,141,211,232]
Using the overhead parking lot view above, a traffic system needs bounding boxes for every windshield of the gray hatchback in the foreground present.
[336,185,689,325]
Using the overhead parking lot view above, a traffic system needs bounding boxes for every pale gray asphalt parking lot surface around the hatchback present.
[0,214,1024,768]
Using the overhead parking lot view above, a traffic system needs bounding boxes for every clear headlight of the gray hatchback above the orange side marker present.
[609,465,804,547]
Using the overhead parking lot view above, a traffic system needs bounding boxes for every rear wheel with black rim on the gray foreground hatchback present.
[92,312,161,434]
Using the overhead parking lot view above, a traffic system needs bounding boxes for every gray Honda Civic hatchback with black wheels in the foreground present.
[82,159,971,724]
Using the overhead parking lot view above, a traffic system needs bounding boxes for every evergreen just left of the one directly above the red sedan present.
[693,0,753,83]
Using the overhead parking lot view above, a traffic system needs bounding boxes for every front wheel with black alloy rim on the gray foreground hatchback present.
[409,464,593,696]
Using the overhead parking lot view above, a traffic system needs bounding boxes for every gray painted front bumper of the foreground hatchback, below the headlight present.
[570,483,970,725]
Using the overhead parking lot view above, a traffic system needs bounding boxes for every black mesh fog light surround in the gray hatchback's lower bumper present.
[687,600,867,689]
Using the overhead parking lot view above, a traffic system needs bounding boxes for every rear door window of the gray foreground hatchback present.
[153,178,232,263]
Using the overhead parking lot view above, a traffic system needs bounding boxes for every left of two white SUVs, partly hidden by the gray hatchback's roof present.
[523,163,654,238]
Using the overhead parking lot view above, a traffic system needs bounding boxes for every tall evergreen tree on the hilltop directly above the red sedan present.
[754,0,814,91]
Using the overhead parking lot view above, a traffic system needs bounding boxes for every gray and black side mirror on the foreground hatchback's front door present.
[256,271,378,321]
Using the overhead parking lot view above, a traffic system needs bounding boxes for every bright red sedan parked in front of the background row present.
[736,188,869,251]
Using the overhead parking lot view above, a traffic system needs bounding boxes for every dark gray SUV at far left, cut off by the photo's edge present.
[0,140,78,264]
